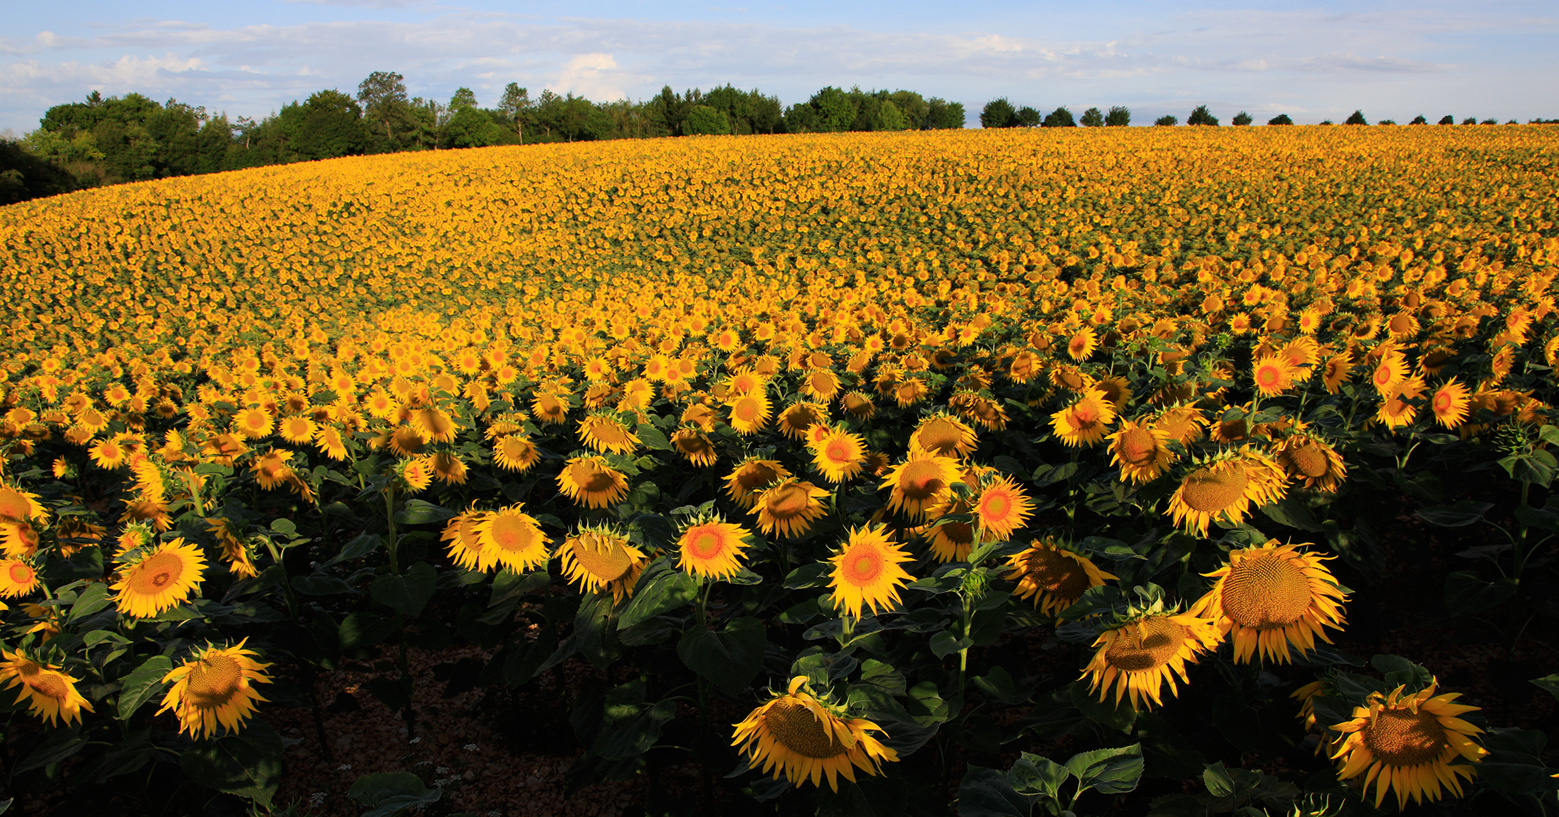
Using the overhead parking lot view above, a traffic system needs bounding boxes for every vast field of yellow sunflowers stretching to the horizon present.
[0,125,1559,817]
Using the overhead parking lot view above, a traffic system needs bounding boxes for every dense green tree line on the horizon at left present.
[0,72,963,204]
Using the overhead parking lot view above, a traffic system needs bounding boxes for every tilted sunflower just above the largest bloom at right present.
[1169,447,1288,536]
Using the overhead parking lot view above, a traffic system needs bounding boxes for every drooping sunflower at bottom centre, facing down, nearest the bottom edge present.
[731,675,898,792]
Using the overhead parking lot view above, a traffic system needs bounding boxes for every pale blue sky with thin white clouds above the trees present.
[0,0,1559,136]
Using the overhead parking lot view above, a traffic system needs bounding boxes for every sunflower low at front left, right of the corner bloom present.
[157,639,271,737]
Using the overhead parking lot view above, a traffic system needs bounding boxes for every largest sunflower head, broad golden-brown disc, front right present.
[1191,539,1347,664]
